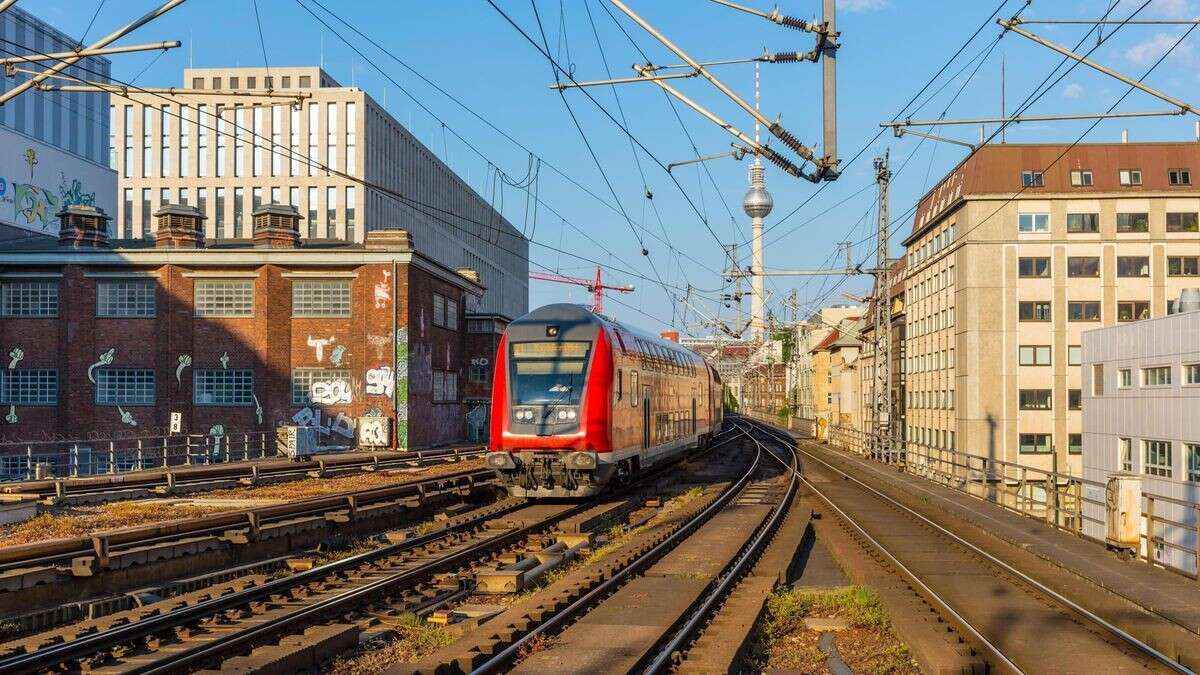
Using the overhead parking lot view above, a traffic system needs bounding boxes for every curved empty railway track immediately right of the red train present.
[422,425,798,674]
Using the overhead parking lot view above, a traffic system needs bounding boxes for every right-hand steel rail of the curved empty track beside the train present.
[643,422,800,674]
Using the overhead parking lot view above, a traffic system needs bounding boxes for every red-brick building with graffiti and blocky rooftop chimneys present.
[0,204,484,456]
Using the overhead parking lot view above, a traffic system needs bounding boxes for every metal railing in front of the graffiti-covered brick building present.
[0,430,276,480]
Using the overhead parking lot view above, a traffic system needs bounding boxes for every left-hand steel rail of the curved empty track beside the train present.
[472,430,762,675]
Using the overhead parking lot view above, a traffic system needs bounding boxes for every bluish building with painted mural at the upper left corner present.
[0,7,116,243]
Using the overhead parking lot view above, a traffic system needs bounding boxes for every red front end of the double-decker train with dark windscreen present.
[487,304,616,497]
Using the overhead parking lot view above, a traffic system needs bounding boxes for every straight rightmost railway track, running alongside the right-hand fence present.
[758,424,1192,673]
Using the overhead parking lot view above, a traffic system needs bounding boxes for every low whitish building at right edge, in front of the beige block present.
[1082,291,1200,574]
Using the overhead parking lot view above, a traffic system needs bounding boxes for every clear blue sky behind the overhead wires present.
[18,0,1200,335]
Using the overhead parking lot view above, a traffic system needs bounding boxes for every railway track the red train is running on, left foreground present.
[0,492,584,673]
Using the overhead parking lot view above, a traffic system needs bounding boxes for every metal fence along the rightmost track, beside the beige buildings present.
[743,411,1200,579]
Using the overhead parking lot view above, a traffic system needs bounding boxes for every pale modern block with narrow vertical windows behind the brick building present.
[110,67,529,319]
